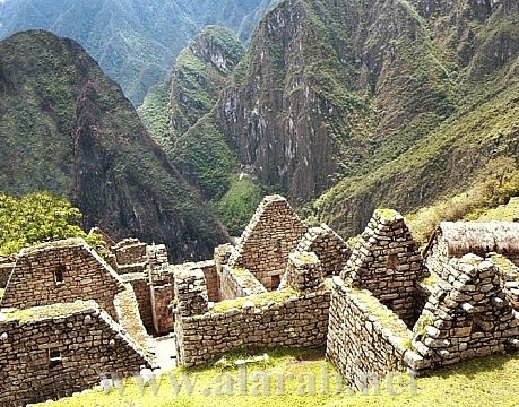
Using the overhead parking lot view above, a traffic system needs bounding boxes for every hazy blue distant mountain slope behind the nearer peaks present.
[0,0,275,105]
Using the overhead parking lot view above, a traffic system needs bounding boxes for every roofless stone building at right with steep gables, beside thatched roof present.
[327,210,519,389]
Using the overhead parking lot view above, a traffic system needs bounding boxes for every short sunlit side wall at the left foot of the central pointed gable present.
[218,266,267,301]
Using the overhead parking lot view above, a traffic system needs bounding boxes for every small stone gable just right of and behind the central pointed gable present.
[297,223,351,277]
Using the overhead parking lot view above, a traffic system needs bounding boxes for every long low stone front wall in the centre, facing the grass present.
[175,292,330,366]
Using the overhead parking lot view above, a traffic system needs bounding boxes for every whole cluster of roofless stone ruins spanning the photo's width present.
[0,195,519,407]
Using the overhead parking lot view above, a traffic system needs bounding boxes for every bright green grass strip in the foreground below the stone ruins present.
[34,351,519,407]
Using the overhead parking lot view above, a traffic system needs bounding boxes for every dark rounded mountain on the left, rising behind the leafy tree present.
[0,31,228,261]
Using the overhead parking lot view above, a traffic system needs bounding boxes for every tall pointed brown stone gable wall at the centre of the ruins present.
[229,195,306,291]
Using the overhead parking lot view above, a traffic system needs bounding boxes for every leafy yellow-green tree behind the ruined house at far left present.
[0,192,101,255]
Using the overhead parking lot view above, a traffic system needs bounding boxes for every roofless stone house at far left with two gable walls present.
[0,239,154,406]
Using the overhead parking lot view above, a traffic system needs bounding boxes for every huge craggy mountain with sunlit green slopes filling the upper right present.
[147,0,519,241]
